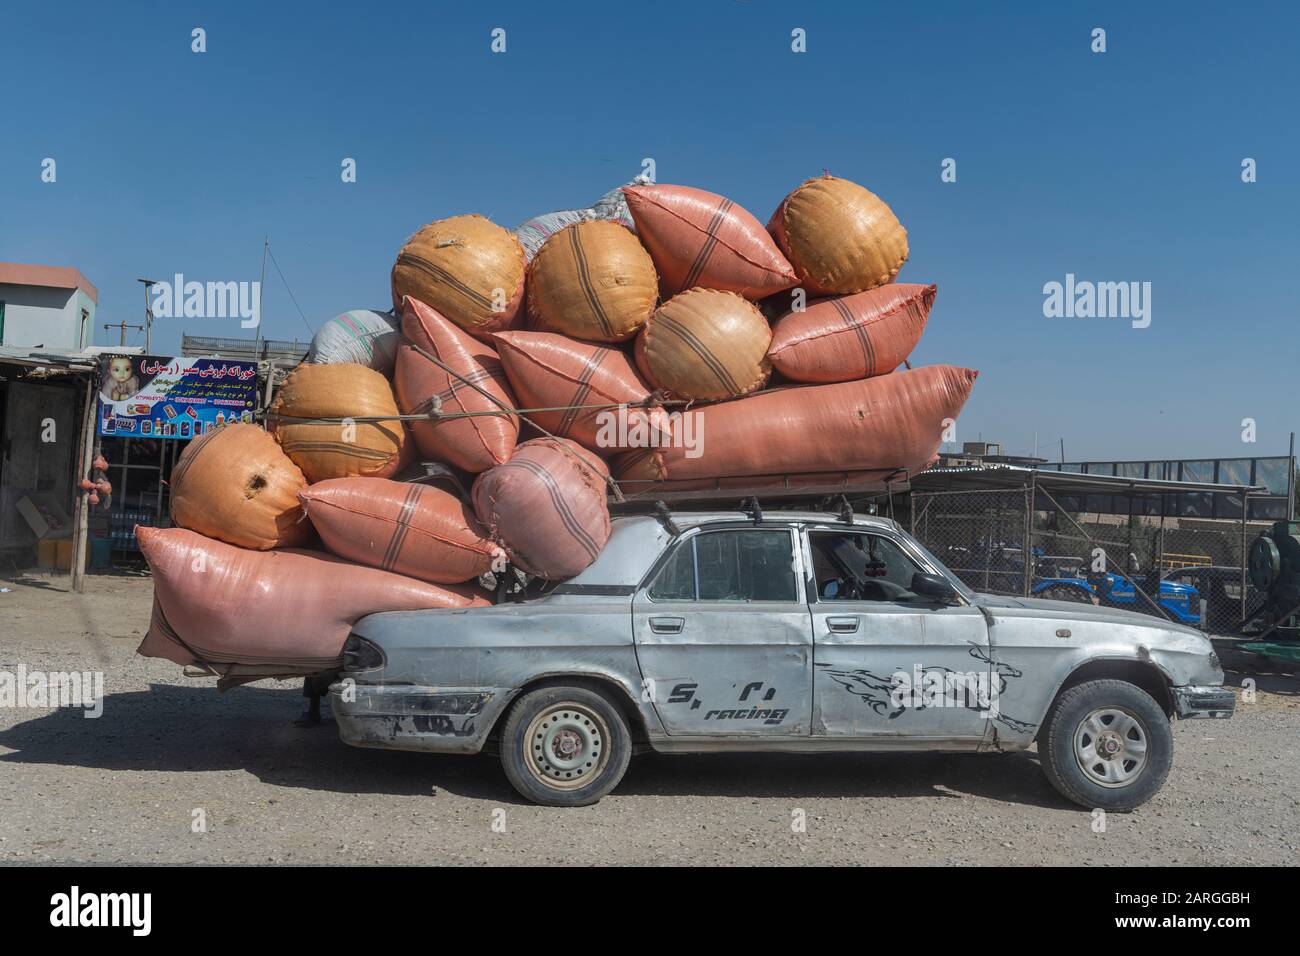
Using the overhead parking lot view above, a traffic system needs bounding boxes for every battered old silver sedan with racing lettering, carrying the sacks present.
[330,510,1235,810]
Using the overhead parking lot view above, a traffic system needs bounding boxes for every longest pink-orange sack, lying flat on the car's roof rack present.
[615,365,978,481]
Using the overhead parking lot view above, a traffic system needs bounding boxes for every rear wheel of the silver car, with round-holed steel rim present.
[501,687,632,806]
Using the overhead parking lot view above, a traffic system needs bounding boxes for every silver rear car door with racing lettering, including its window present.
[632,524,813,736]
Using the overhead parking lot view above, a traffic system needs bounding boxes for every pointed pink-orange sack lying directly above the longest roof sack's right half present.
[767,282,935,382]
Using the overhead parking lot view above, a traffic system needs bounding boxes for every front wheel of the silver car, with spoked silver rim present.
[1039,680,1174,812]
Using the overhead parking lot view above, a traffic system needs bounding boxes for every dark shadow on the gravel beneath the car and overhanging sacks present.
[0,684,1070,809]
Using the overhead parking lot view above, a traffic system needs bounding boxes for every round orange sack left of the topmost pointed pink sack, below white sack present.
[528,220,659,342]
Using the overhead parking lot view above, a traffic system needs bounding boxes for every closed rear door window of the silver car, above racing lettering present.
[647,528,798,601]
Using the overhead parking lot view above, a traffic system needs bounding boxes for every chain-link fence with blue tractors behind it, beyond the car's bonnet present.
[910,488,1265,635]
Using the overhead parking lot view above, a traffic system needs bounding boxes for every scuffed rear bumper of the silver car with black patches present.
[329,680,510,753]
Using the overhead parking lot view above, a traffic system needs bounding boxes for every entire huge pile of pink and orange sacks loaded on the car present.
[139,167,975,675]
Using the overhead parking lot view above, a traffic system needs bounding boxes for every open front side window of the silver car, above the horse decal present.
[809,531,922,602]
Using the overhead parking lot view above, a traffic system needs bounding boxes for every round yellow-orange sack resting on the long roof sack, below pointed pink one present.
[636,289,772,399]
